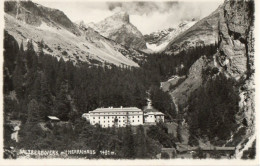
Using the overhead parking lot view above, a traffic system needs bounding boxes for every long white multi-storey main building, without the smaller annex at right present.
[82,107,144,127]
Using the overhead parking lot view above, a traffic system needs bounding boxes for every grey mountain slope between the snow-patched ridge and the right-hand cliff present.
[163,6,222,54]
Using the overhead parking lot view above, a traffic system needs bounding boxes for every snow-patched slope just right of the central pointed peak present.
[144,19,197,52]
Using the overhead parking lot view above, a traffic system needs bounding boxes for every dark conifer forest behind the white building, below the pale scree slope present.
[4,28,218,122]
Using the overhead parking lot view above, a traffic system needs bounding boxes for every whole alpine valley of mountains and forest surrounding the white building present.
[3,0,256,159]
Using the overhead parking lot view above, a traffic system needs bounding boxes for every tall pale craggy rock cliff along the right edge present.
[216,0,255,146]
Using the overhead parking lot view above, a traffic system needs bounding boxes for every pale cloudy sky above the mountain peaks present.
[32,0,223,34]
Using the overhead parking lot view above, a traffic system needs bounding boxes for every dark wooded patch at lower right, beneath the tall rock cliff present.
[187,73,240,146]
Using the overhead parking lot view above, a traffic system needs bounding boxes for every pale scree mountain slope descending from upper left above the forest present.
[5,1,142,67]
